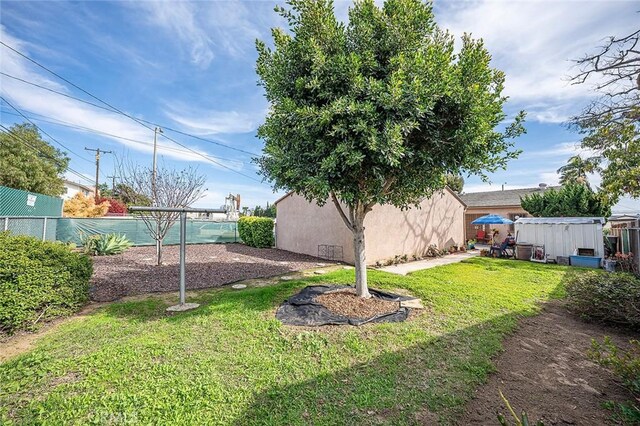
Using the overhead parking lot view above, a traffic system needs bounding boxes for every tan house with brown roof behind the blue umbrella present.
[460,183,560,240]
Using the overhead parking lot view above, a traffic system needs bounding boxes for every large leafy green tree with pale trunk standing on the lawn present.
[257,0,523,297]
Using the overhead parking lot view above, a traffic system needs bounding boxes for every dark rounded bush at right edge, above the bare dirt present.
[566,271,640,329]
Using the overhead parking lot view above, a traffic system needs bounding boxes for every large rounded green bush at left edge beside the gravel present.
[0,232,93,334]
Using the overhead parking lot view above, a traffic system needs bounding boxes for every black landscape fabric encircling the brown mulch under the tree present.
[276,285,414,326]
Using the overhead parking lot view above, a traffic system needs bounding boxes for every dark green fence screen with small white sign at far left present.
[0,186,62,217]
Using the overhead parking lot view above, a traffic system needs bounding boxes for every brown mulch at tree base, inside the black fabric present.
[315,289,399,318]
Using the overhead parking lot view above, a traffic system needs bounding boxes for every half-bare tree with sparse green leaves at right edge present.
[570,29,640,198]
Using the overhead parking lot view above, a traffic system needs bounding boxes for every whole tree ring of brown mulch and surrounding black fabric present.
[276,285,421,326]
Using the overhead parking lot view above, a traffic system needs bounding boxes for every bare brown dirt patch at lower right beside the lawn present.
[459,302,637,425]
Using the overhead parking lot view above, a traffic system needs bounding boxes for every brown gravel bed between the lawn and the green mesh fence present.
[91,244,331,302]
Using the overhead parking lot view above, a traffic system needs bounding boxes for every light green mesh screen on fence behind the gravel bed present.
[56,217,241,246]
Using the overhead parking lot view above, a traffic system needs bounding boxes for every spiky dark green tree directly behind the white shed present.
[521,183,611,217]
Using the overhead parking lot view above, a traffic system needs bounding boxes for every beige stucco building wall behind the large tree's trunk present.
[276,190,464,264]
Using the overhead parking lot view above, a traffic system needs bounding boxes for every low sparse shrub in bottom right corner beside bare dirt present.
[588,336,640,424]
